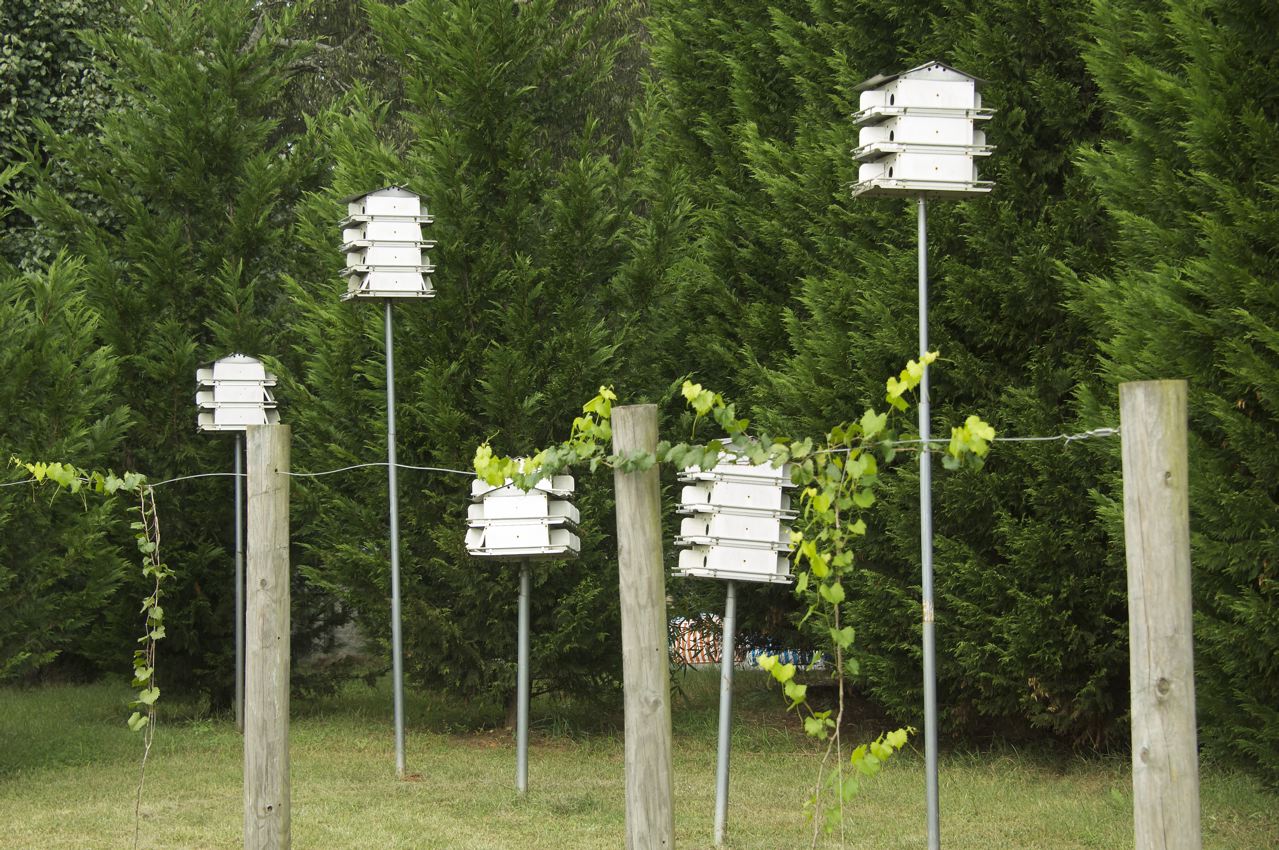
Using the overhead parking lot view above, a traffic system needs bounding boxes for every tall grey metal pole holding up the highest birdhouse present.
[920,194,941,850]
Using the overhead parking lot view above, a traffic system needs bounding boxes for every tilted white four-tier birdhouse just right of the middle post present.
[674,459,796,584]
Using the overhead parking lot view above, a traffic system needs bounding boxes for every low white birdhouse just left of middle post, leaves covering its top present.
[467,475,582,560]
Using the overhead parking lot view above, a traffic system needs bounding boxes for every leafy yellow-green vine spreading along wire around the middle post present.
[475,352,995,845]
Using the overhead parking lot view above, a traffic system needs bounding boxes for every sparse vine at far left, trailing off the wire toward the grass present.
[10,458,173,846]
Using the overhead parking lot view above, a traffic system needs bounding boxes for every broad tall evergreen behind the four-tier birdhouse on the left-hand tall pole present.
[283,0,625,698]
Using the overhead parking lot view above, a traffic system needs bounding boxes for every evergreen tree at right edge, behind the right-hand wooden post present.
[1078,0,1279,778]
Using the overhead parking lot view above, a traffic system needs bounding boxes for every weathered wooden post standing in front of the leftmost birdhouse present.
[244,424,289,850]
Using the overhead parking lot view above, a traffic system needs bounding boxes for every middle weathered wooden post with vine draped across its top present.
[613,404,675,850]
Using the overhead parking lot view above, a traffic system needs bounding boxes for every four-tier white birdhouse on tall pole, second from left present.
[341,185,435,300]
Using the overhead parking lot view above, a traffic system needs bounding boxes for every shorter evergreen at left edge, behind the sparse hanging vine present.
[0,249,129,681]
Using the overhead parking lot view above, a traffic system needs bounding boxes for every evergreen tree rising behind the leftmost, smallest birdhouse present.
[23,0,324,704]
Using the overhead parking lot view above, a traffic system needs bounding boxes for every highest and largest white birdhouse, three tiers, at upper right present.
[853,61,994,196]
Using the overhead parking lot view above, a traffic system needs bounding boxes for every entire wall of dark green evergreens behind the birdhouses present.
[0,0,1279,777]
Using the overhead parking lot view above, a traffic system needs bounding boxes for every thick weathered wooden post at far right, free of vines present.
[1119,381,1201,850]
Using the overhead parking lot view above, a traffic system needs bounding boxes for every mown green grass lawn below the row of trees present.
[0,674,1279,850]
